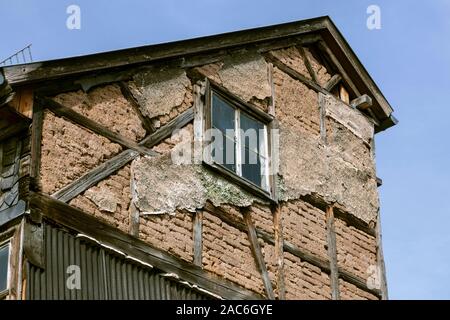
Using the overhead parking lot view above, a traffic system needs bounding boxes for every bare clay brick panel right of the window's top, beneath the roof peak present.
[273,68,320,136]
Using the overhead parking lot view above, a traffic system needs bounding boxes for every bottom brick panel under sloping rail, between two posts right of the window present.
[284,252,331,300]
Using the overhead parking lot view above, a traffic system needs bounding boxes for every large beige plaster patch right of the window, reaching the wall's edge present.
[279,126,379,222]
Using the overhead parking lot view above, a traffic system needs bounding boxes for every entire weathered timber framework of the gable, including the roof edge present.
[0,17,397,300]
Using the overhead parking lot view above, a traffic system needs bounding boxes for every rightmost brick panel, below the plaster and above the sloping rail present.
[335,219,377,279]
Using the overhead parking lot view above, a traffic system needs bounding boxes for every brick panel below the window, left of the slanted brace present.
[203,212,264,294]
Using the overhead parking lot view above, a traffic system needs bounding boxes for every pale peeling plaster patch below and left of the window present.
[132,154,262,215]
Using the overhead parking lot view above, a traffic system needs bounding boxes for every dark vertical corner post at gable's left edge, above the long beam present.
[30,101,44,190]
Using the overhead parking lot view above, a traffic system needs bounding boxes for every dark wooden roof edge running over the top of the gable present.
[4,16,397,132]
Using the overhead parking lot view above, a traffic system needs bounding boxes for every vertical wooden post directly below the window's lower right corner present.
[271,205,286,300]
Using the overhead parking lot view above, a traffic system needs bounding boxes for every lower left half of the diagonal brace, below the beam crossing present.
[52,149,139,202]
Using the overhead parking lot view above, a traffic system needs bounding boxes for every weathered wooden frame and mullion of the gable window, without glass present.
[203,79,276,203]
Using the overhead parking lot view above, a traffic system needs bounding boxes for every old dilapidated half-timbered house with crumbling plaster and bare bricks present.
[0,17,396,299]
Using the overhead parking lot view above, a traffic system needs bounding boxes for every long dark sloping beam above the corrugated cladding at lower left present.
[30,193,262,300]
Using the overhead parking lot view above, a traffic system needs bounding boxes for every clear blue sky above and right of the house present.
[0,0,450,299]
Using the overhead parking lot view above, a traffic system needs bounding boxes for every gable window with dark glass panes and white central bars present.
[208,86,271,195]
